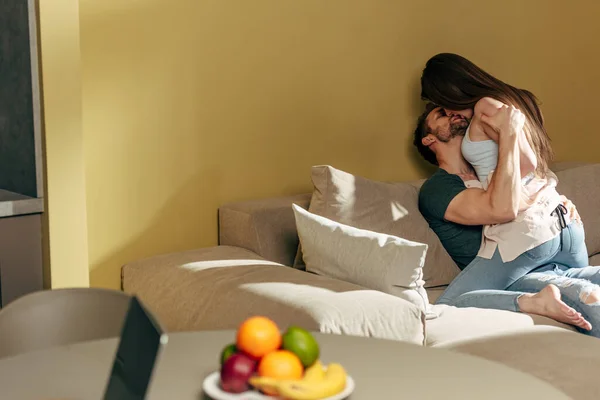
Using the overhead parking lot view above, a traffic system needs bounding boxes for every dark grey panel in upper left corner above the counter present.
[0,0,44,202]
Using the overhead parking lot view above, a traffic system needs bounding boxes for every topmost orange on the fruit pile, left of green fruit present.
[236,316,281,358]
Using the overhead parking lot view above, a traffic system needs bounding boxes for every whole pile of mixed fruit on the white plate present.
[220,316,347,400]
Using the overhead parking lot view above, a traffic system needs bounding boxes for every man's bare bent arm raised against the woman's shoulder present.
[444,105,525,225]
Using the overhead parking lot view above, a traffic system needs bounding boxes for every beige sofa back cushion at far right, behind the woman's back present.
[556,164,600,256]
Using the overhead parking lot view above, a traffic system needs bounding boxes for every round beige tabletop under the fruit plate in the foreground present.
[0,331,568,400]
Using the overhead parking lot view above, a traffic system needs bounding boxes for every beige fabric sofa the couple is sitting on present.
[122,163,600,399]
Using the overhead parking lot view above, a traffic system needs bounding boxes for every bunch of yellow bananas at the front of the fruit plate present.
[250,362,347,400]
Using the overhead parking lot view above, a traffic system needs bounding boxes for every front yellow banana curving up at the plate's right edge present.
[277,363,346,400]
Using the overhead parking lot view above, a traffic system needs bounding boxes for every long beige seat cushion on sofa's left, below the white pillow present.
[123,246,425,345]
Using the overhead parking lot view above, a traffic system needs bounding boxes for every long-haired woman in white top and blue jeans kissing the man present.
[421,53,600,335]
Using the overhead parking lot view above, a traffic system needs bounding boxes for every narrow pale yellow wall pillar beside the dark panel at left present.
[39,0,89,288]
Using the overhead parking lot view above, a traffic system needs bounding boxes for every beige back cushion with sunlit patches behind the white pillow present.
[295,165,460,287]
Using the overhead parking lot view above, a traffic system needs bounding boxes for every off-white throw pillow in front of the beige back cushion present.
[292,204,429,313]
